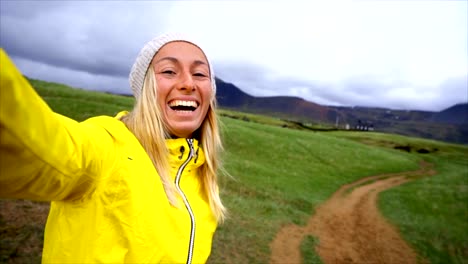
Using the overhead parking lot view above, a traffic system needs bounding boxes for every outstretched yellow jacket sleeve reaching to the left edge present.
[0,49,112,201]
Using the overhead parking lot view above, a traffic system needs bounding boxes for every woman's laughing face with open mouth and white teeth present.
[151,41,213,138]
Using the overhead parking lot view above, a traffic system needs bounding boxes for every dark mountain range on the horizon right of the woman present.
[216,79,468,144]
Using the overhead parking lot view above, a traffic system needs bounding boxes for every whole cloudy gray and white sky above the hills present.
[0,0,468,111]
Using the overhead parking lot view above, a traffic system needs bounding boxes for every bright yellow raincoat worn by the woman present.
[0,49,216,263]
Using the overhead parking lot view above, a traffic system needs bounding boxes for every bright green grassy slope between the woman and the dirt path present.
[208,118,424,263]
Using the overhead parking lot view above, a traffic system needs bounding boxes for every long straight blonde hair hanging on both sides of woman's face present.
[122,64,226,223]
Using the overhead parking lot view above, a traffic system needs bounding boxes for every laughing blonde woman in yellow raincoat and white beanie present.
[0,34,225,263]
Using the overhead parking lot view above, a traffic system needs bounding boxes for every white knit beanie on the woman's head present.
[129,33,216,98]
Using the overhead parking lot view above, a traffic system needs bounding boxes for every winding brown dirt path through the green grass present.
[270,162,435,264]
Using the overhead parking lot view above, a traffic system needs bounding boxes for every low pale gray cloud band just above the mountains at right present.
[215,62,468,111]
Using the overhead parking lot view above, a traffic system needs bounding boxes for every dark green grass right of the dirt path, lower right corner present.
[379,145,468,263]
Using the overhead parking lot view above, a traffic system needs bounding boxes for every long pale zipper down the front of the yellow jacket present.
[175,138,195,264]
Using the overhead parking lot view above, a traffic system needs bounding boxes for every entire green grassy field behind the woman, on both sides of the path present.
[0,77,468,263]
